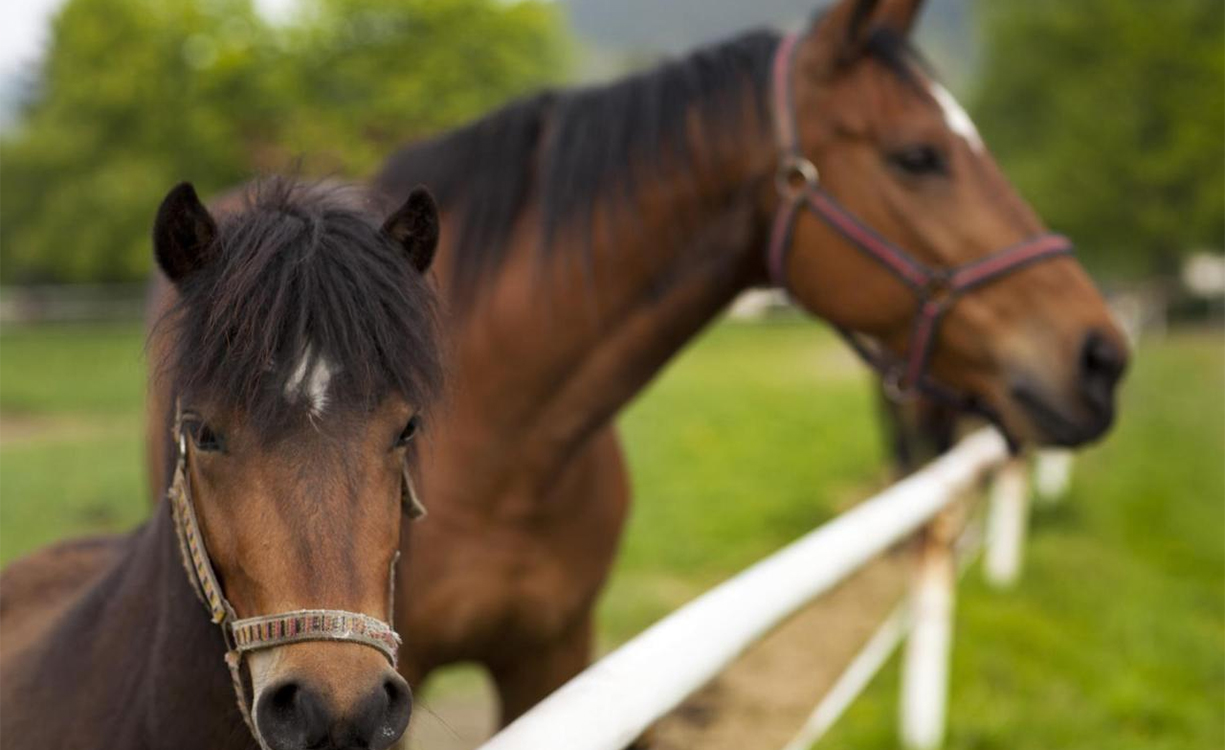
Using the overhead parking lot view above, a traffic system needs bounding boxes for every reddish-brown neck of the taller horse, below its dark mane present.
[436,136,772,502]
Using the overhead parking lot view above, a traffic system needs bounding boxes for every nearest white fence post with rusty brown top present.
[900,510,957,750]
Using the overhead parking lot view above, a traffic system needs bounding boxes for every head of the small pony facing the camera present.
[154,181,440,750]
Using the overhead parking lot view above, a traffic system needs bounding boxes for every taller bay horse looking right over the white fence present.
[152,0,1127,723]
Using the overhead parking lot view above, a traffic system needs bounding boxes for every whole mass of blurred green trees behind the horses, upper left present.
[0,0,567,283]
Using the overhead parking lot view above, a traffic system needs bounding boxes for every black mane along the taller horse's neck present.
[376,31,779,305]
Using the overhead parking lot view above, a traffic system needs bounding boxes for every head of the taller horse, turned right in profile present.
[774,0,1127,445]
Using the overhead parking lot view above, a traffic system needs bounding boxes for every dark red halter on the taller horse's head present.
[766,34,1072,408]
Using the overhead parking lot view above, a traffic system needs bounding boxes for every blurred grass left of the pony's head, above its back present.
[0,325,148,563]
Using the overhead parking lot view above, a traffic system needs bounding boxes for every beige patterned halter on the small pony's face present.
[167,404,425,750]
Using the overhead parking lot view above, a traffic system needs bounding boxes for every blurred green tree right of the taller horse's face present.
[974,0,1225,276]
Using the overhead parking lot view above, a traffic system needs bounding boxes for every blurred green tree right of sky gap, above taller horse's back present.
[277,0,568,174]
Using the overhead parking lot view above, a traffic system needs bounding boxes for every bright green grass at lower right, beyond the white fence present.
[820,333,1225,750]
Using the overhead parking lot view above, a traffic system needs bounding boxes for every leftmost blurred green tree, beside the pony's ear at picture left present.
[0,0,279,282]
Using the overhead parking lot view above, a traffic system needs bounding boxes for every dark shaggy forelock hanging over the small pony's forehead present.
[159,179,441,438]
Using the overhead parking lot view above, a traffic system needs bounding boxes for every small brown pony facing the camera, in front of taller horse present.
[0,179,441,750]
